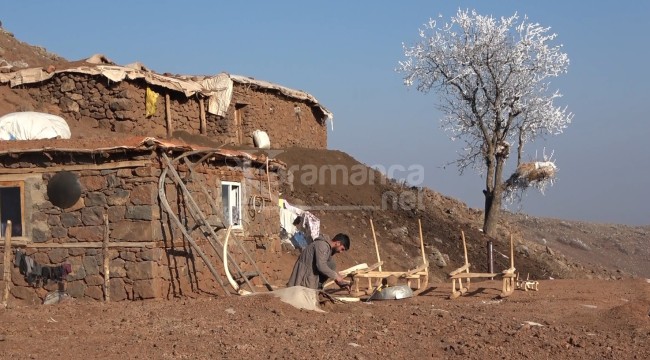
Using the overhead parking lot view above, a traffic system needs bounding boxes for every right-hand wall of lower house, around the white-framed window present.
[157,164,280,298]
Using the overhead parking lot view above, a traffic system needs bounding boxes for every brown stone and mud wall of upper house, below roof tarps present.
[16,73,327,149]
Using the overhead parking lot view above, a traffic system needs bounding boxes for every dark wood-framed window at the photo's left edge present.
[0,181,25,238]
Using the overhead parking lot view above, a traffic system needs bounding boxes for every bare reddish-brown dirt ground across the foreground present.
[0,280,650,360]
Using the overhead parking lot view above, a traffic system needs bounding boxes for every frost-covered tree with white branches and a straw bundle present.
[397,10,573,236]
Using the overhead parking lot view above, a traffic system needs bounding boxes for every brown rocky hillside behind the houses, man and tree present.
[0,29,650,279]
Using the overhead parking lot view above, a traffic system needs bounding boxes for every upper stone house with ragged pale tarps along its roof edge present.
[0,56,332,149]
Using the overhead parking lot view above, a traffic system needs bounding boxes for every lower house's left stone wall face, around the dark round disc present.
[0,159,164,303]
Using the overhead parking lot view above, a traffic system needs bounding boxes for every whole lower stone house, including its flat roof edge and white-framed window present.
[0,136,284,303]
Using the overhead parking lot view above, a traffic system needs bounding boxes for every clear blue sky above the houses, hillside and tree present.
[5,0,650,225]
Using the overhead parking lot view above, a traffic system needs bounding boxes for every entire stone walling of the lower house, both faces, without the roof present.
[0,150,279,304]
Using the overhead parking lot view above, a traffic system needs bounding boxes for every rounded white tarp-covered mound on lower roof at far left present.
[0,111,70,140]
